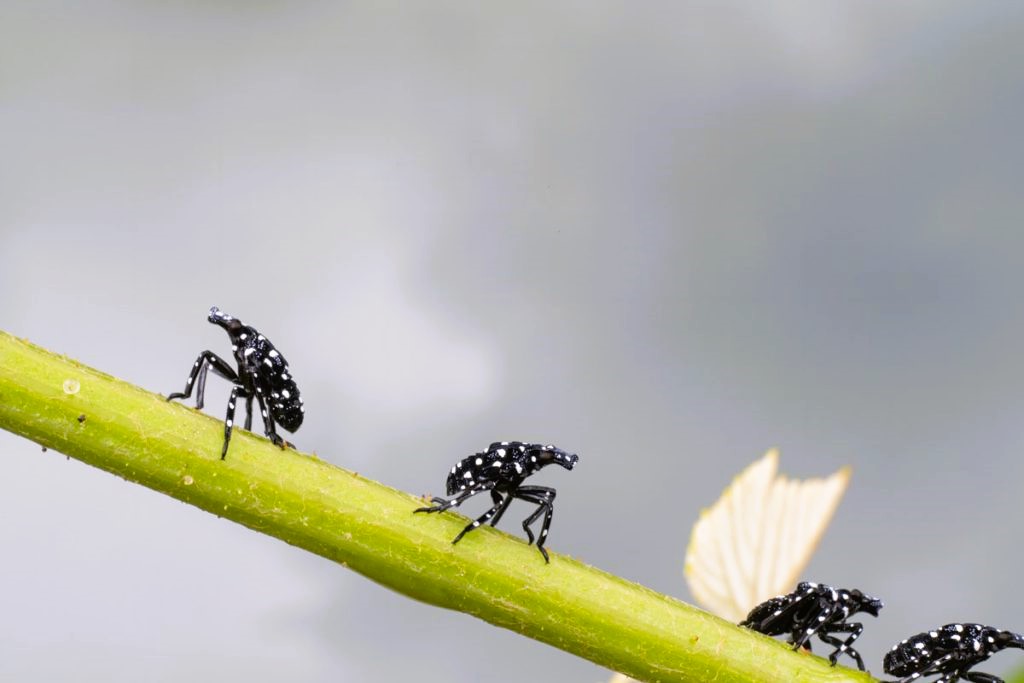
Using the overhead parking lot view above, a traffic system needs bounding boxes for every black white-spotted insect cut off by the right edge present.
[883,624,1024,683]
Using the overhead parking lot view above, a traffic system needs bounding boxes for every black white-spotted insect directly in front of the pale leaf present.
[739,581,883,671]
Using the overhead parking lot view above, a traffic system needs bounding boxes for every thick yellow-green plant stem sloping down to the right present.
[0,332,873,683]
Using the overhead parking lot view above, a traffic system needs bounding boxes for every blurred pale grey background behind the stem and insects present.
[0,0,1024,683]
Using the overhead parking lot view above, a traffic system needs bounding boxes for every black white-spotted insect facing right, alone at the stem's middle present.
[416,441,580,562]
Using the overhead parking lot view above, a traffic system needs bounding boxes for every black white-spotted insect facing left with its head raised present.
[167,306,305,460]
